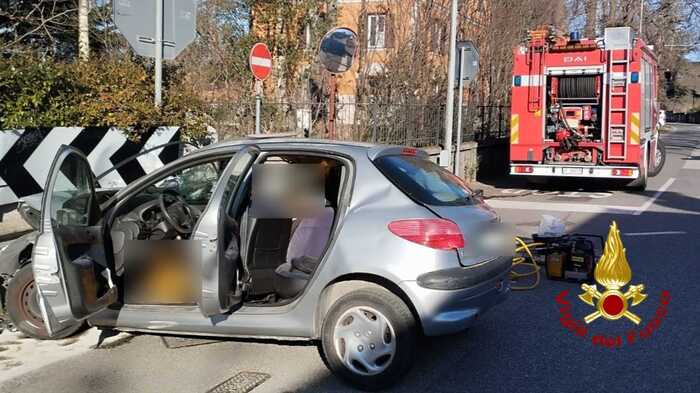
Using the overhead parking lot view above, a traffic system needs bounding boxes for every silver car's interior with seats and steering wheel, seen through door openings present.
[110,154,345,306]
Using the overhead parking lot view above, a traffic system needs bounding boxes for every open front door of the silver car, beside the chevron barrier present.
[32,145,117,336]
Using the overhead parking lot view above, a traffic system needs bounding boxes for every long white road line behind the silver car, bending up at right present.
[486,177,676,216]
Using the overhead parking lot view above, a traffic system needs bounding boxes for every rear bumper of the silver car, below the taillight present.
[401,257,511,336]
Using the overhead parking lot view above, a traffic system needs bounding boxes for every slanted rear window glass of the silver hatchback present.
[374,155,472,206]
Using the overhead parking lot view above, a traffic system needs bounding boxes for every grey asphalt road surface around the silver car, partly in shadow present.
[0,125,700,393]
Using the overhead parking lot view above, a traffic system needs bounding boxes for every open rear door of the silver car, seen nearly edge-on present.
[193,145,260,317]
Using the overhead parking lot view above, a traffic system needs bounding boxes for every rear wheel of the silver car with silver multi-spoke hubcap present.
[320,288,418,391]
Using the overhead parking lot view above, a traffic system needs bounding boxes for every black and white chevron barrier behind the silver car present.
[0,127,180,214]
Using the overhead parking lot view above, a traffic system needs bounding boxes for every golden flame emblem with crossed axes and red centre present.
[578,221,647,325]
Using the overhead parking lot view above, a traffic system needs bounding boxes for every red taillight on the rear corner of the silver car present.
[389,218,464,250]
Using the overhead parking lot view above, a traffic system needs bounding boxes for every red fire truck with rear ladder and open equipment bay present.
[510,27,665,189]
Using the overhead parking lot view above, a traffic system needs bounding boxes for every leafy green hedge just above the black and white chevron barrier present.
[0,55,205,138]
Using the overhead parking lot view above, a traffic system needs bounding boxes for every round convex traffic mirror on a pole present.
[319,27,357,74]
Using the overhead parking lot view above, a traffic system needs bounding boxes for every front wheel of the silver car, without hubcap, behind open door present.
[6,263,82,340]
